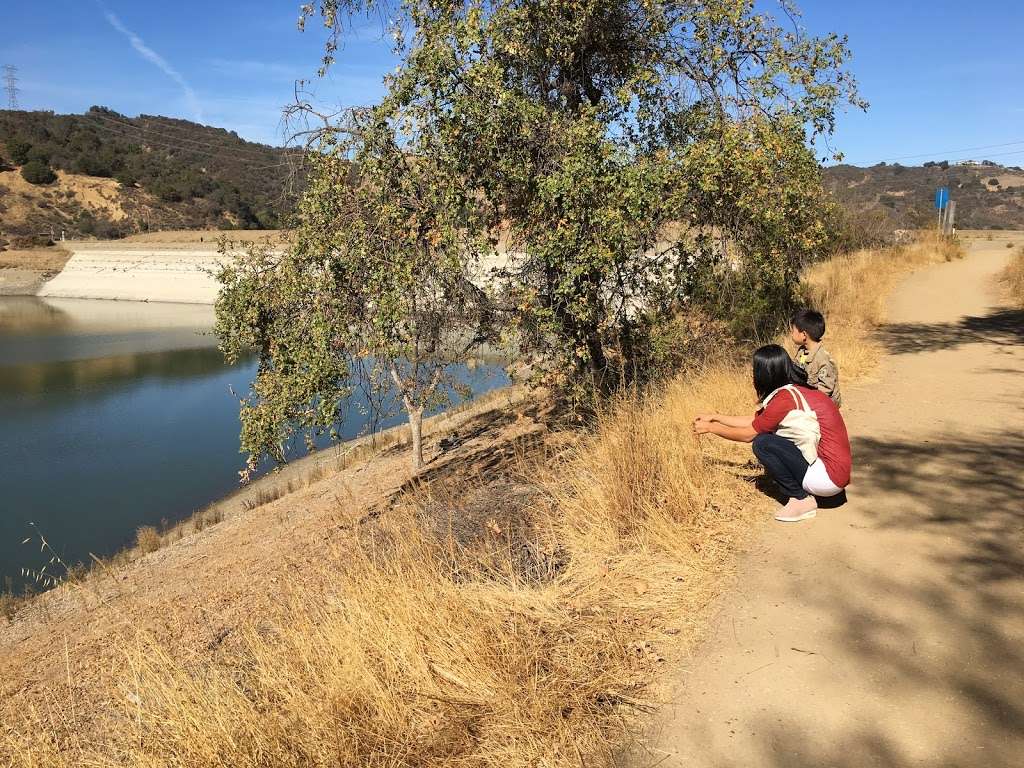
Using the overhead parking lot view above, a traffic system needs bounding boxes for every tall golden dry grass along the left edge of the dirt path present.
[0,234,946,768]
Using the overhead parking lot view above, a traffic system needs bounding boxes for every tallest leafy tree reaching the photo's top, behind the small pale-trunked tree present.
[304,0,862,393]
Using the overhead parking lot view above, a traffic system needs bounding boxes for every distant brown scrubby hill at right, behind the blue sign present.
[824,161,1024,229]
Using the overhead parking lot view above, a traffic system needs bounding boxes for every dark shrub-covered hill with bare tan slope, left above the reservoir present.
[0,106,302,244]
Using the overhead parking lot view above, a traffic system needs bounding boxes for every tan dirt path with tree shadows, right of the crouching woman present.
[641,241,1024,768]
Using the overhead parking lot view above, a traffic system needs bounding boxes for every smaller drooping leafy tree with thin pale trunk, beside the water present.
[217,111,490,477]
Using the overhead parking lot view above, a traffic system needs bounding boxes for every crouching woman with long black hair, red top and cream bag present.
[693,344,852,522]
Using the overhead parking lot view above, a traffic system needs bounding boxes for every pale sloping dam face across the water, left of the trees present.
[38,243,225,304]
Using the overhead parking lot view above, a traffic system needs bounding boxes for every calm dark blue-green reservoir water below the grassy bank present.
[0,297,508,591]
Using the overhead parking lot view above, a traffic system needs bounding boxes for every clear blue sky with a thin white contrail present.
[0,0,1024,165]
